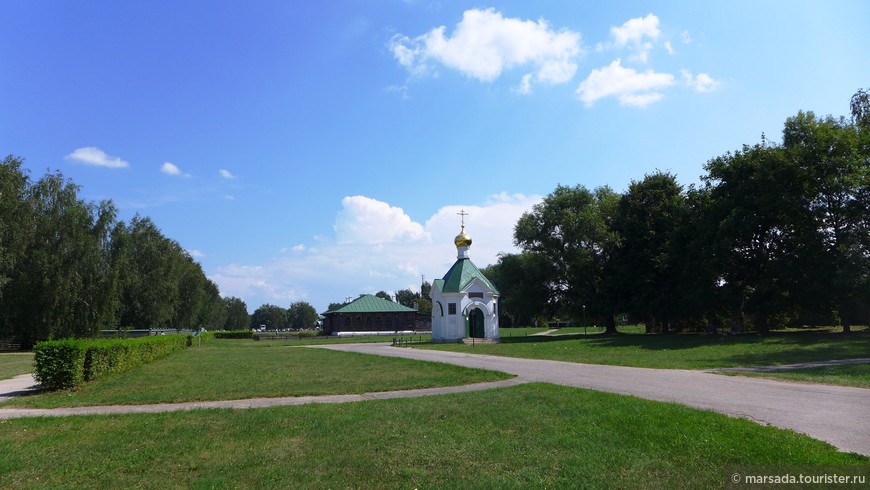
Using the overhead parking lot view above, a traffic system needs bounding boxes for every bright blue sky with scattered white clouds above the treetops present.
[0,0,870,311]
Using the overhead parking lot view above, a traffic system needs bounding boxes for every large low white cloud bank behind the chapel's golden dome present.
[209,193,541,311]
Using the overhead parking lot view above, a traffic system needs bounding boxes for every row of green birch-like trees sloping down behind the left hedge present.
[0,156,249,347]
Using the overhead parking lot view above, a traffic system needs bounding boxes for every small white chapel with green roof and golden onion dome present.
[429,210,499,342]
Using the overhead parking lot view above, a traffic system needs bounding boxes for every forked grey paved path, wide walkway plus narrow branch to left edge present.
[0,343,870,456]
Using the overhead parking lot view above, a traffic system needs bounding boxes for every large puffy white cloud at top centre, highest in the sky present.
[388,8,581,90]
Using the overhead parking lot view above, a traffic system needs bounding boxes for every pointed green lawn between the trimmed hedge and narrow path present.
[2,340,511,408]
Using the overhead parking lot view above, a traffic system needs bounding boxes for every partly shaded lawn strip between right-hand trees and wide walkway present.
[417,330,870,369]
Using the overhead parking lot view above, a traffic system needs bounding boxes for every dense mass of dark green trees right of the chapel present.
[485,104,870,332]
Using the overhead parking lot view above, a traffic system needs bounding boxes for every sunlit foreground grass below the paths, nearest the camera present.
[0,384,868,489]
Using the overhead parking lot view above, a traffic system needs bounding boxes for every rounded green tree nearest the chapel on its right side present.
[514,185,619,333]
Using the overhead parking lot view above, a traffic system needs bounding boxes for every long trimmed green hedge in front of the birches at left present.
[33,335,191,390]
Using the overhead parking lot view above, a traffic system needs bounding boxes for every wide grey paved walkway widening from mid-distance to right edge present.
[314,344,870,456]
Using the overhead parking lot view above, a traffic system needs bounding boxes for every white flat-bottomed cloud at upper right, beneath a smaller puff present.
[577,59,674,107]
